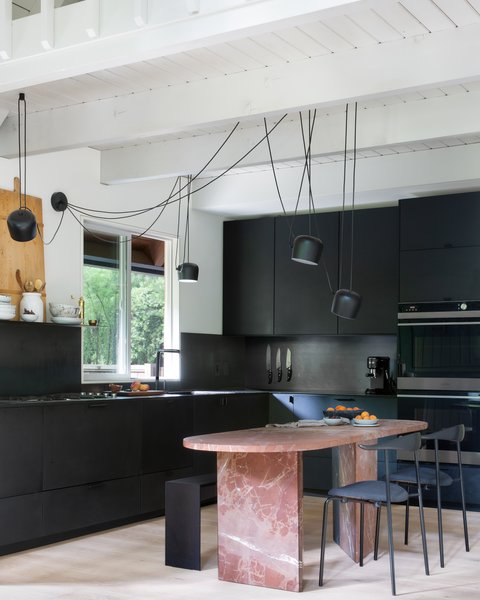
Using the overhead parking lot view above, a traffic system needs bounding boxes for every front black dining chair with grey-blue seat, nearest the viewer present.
[318,433,430,596]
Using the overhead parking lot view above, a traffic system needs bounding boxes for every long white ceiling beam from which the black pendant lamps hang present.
[0,25,480,157]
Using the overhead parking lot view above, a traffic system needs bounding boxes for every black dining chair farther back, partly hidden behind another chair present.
[390,424,470,567]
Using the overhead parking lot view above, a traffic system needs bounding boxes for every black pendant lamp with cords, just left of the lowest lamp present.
[292,111,323,266]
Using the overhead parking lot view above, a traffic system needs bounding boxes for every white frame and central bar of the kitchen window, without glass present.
[81,219,180,383]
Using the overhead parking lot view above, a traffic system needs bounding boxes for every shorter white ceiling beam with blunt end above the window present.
[100,92,480,184]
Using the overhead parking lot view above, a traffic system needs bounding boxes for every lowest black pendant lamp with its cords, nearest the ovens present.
[331,102,362,319]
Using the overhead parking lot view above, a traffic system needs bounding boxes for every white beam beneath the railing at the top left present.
[0,0,360,92]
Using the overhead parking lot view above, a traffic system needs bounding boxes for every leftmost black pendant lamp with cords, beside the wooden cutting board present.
[7,92,37,242]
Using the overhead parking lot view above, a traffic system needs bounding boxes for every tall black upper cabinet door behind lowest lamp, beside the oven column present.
[338,206,399,335]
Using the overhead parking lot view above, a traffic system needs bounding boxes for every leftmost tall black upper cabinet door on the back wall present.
[223,218,274,335]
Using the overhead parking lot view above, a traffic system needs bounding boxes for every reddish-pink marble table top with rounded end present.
[183,419,428,452]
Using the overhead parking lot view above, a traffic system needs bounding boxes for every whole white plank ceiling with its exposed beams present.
[0,0,480,217]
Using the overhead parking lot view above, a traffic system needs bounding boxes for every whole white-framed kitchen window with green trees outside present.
[83,223,179,380]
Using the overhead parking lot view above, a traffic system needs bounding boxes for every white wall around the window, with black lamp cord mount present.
[0,148,223,334]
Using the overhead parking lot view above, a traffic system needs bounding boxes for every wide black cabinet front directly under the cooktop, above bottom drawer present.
[43,399,141,489]
